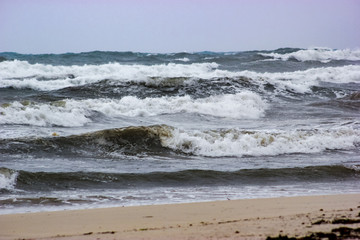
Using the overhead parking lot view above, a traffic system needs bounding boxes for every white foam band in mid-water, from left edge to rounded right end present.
[0,91,267,127]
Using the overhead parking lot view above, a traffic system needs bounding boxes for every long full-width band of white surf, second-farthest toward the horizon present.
[0,60,360,97]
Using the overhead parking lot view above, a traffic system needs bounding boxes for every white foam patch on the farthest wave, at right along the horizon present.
[259,48,360,63]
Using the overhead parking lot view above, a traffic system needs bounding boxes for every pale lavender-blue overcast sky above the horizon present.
[0,0,360,54]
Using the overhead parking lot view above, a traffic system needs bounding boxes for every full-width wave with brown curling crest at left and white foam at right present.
[1,125,360,157]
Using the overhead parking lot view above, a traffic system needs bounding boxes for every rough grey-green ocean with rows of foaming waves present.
[0,48,360,214]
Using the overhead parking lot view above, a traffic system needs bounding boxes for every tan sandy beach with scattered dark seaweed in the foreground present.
[0,194,360,239]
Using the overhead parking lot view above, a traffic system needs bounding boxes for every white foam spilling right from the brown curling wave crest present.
[162,127,360,157]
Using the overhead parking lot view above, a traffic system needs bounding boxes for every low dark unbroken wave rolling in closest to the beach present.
[0,165,359,193]
